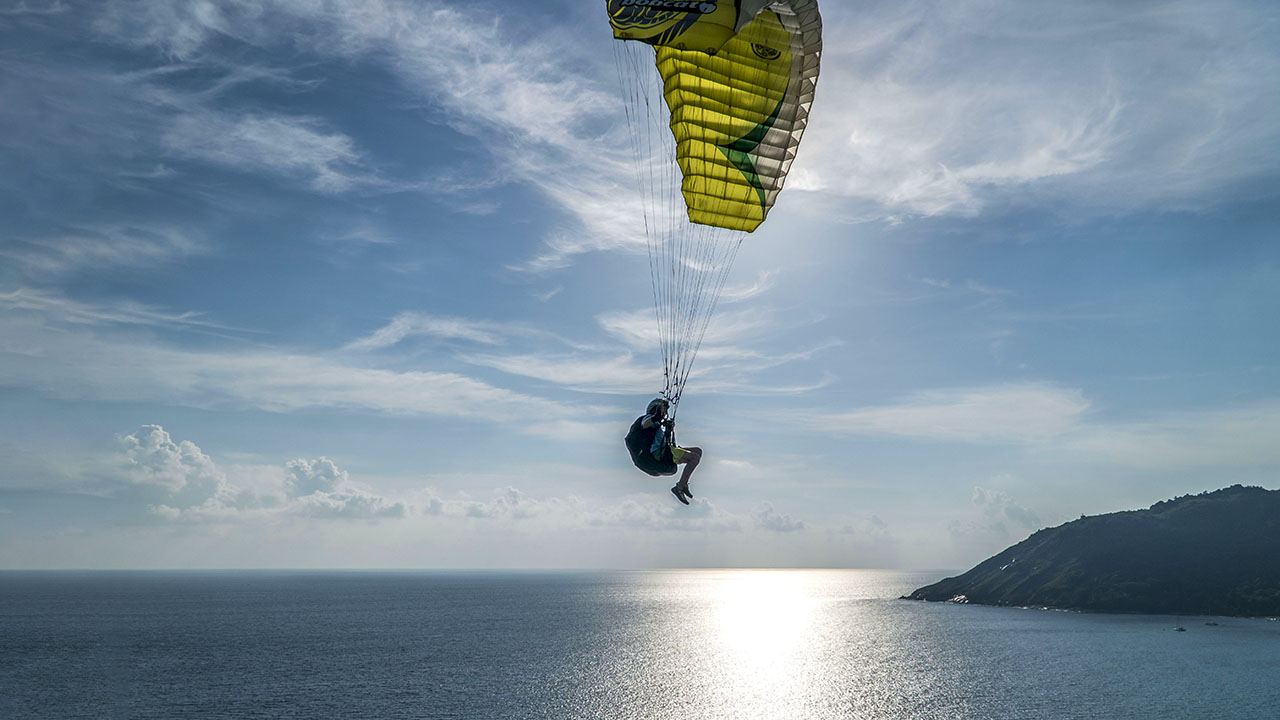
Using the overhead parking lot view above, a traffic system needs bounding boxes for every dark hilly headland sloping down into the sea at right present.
[904,486,1280,616]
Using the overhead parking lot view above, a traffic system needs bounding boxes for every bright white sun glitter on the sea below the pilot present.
[593,570,947,719]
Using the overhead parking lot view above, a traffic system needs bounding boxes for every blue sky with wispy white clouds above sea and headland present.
[0,0,1280,569]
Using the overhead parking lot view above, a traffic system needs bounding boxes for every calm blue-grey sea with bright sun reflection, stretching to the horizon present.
[0,570,1280,720]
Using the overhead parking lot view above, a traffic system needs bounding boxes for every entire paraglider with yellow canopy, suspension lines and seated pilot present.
[607,0,822,503]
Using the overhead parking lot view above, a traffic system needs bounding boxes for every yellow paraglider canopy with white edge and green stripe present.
[608,0,822,232]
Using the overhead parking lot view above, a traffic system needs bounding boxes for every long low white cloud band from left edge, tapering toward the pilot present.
[0,310,612,427]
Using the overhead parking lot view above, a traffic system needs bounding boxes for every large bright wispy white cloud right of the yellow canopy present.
[790,1,1280,219]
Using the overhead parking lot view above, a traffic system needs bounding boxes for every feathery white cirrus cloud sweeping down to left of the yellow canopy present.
[73,1,644,270]
